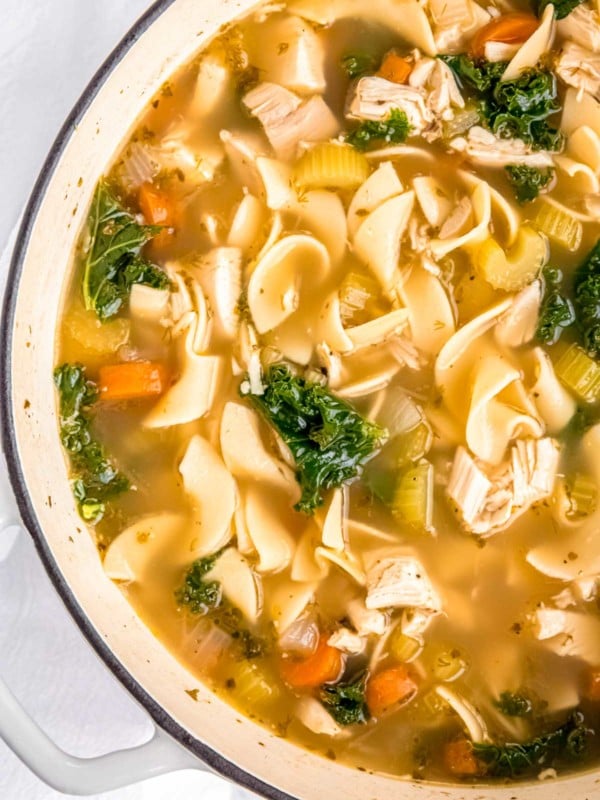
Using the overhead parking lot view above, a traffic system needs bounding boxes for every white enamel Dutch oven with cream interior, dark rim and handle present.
[0,0,600,800]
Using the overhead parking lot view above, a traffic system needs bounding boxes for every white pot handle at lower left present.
[0,462,206,796]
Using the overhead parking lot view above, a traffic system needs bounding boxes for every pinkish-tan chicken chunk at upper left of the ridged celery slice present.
[243,83,340,160]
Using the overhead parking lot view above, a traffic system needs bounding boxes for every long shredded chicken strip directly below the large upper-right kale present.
[450,125,553,168]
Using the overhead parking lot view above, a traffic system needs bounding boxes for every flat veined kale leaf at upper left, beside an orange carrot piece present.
[83,181,169,321]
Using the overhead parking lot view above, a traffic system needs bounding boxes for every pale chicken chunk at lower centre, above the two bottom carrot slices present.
[366,555,442,611]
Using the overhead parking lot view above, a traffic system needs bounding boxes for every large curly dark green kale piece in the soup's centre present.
[246,364,386,514]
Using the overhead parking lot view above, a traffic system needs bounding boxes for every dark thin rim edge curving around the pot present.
[0,0,295,800]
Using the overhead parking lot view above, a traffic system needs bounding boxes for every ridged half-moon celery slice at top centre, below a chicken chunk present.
[292,142,370,189]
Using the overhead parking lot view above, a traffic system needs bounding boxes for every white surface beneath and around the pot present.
[0,0,250,800]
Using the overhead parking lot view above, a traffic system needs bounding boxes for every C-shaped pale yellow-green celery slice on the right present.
[472,225,548,292]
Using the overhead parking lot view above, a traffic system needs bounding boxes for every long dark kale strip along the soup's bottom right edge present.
[473,712,593,777]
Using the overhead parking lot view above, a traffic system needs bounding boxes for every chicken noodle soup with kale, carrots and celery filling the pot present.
[55,0,600,782]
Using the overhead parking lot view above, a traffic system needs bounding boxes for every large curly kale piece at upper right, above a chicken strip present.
[440,53,564,150]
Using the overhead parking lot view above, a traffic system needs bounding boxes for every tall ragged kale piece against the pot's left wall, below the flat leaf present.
[54,364,129,523]
